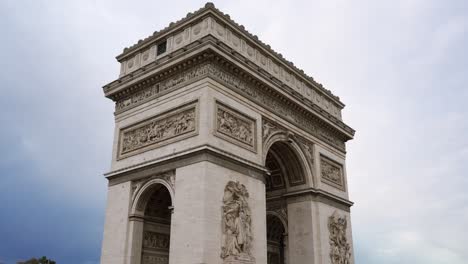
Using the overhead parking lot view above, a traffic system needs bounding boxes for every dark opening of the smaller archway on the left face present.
[141,184,172,264]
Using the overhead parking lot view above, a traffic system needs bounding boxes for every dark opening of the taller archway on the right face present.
[265,141,305,264]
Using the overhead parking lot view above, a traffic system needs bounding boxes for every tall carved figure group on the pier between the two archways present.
[221,181,254,263]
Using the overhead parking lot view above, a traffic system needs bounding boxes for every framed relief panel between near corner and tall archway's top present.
[214,101,257,152]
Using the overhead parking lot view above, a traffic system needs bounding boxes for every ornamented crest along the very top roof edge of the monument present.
[116,2,345,105]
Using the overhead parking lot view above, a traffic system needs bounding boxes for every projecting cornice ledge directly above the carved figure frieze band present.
[104,40,355,140]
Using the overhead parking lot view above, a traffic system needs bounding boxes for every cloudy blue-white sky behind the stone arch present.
[0,0,468,264]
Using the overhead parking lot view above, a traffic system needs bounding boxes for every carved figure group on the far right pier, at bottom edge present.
[328,211,351,264]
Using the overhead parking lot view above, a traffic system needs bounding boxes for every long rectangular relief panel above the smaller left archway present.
[118,103,198,158]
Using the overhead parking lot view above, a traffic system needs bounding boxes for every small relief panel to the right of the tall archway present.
[320,154,346,191]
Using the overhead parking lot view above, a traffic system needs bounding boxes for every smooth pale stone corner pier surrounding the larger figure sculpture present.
[169,161,266,264]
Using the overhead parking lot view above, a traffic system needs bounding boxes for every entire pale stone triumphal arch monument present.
[101,3,354,264]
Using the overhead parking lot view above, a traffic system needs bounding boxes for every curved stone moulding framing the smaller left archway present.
[130,178,174,216]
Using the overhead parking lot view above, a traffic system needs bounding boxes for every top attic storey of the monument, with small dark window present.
[104,3,344,120]
